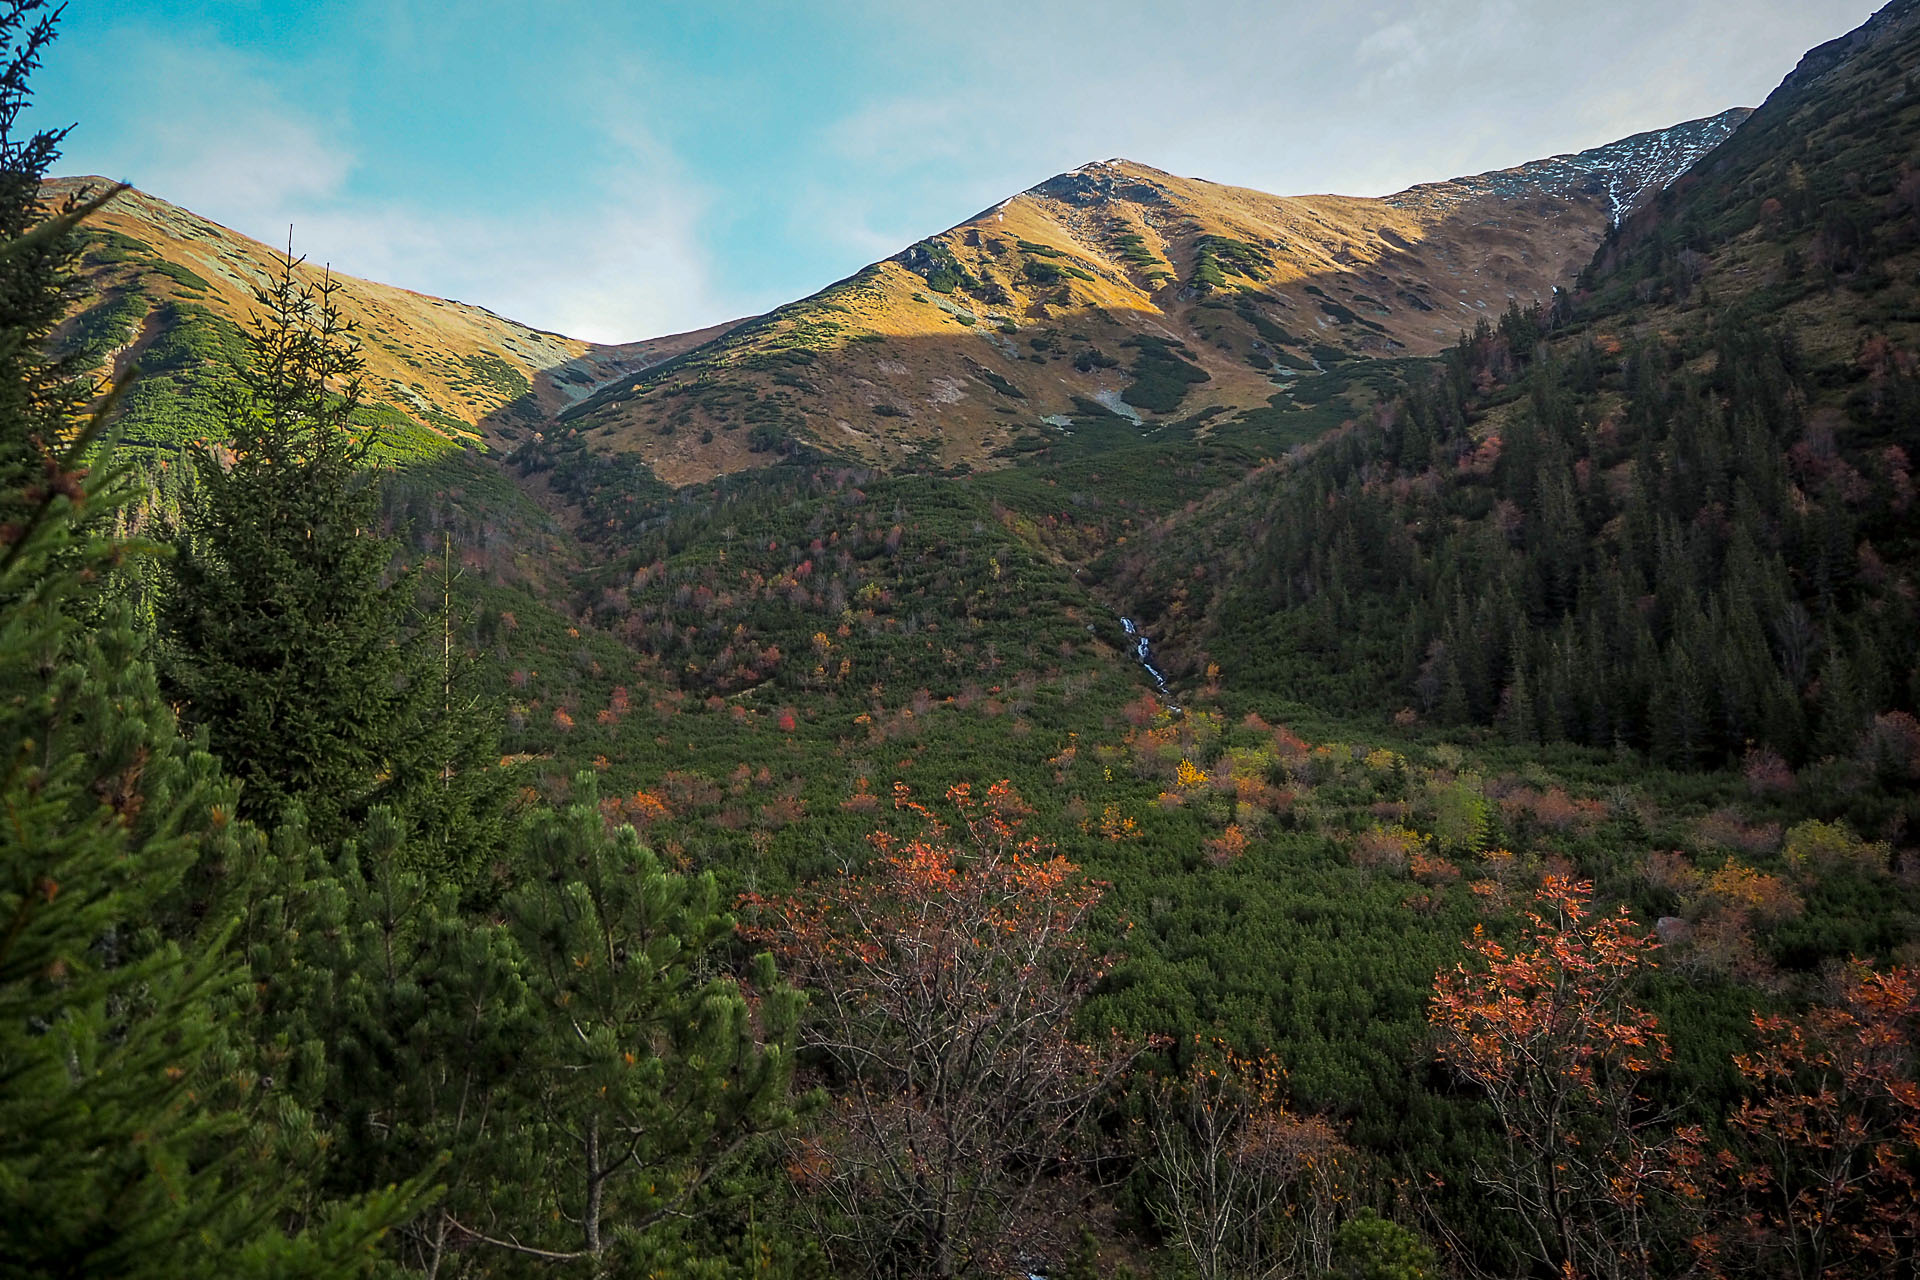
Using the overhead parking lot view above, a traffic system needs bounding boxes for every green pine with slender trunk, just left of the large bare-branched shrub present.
[478,773,801,1265]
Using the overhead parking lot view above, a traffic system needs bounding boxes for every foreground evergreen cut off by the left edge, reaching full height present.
[0,0,409,1278]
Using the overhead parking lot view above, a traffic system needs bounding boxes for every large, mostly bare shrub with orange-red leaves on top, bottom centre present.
[745,783,1131,1276]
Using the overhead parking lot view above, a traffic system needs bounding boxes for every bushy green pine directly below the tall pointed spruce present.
[244,802,543,1274]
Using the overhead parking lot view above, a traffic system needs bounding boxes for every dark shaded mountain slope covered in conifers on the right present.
[1106,0,1920,782]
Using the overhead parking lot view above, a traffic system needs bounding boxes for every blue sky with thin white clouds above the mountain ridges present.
[29,0,1876,342]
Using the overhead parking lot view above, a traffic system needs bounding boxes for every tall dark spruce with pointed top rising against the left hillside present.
[159,253,499,864]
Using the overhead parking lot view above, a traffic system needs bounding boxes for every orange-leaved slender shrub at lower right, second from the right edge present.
[1427,875,1672,1278]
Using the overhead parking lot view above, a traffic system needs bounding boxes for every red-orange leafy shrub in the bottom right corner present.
[1688,961,1920,1280]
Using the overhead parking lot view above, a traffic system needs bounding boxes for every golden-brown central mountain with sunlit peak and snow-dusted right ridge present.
[563,111,1745,482]
